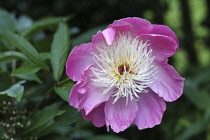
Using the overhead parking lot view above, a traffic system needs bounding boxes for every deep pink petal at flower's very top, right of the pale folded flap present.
[120,17,152,36]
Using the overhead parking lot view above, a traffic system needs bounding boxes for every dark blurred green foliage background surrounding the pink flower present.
[0,0,210,140]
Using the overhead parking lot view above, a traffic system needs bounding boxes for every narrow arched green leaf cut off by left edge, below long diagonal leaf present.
[0,51,28,62]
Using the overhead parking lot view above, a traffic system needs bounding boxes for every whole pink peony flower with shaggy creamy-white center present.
[66,17,184,133]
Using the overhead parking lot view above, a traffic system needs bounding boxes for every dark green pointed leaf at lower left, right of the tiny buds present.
[24,103,65,134]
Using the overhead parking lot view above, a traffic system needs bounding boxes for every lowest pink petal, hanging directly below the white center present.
[104,97,138,133]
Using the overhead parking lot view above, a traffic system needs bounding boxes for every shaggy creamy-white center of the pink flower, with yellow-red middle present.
[91,34,157,103]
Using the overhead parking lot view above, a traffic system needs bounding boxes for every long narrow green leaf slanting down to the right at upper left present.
[4,31,48,69]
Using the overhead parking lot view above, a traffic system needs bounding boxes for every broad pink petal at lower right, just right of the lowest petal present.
[133,90,166,130]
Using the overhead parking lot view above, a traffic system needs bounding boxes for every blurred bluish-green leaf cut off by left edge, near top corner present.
[0,9,16,33]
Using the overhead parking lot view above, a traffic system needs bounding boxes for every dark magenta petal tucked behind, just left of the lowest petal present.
[81,103,105,127]
